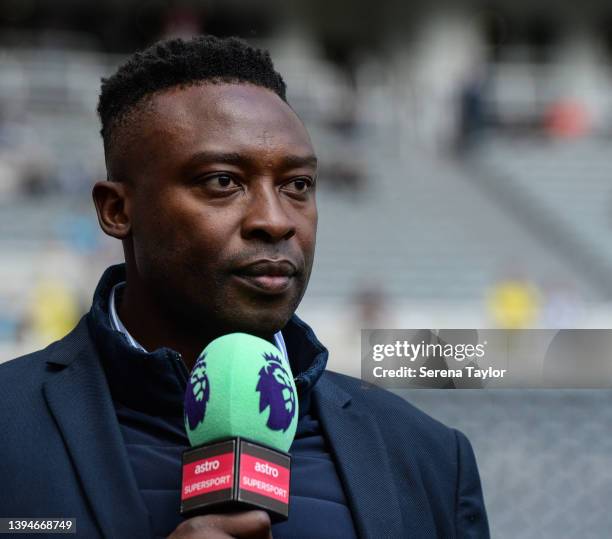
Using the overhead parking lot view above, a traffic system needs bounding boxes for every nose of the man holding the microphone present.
[242,183,295,243]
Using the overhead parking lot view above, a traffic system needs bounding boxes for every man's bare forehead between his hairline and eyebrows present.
[139,83,313,165]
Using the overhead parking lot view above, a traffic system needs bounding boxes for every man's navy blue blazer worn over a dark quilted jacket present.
[0,317,489,539]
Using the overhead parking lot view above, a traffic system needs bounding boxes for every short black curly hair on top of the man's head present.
[98,35,287,154]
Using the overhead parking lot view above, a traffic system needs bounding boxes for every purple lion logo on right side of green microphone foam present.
[256,353,295,432]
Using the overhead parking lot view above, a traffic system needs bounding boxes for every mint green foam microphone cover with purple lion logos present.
[185,333,298,452]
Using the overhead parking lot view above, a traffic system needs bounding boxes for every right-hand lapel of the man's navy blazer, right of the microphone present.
[313,375,406,539]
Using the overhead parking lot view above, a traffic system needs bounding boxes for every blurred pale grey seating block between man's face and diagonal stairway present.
[308,129,600,302]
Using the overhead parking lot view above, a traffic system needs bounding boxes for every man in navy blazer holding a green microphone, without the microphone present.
[0,37,488,539]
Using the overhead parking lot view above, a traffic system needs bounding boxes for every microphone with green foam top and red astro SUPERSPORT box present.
[180,333,298,522]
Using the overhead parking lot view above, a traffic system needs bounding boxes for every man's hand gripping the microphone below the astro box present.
[168,511,272,539]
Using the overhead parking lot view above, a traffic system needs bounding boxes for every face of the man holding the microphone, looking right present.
[113,84,317,335]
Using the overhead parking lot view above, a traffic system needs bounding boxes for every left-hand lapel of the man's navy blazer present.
[43,318,152,537]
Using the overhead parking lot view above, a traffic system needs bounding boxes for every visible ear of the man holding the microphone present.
[91,181,132,240]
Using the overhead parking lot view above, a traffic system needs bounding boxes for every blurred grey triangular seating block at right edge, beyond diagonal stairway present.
[471,138,612,300]
